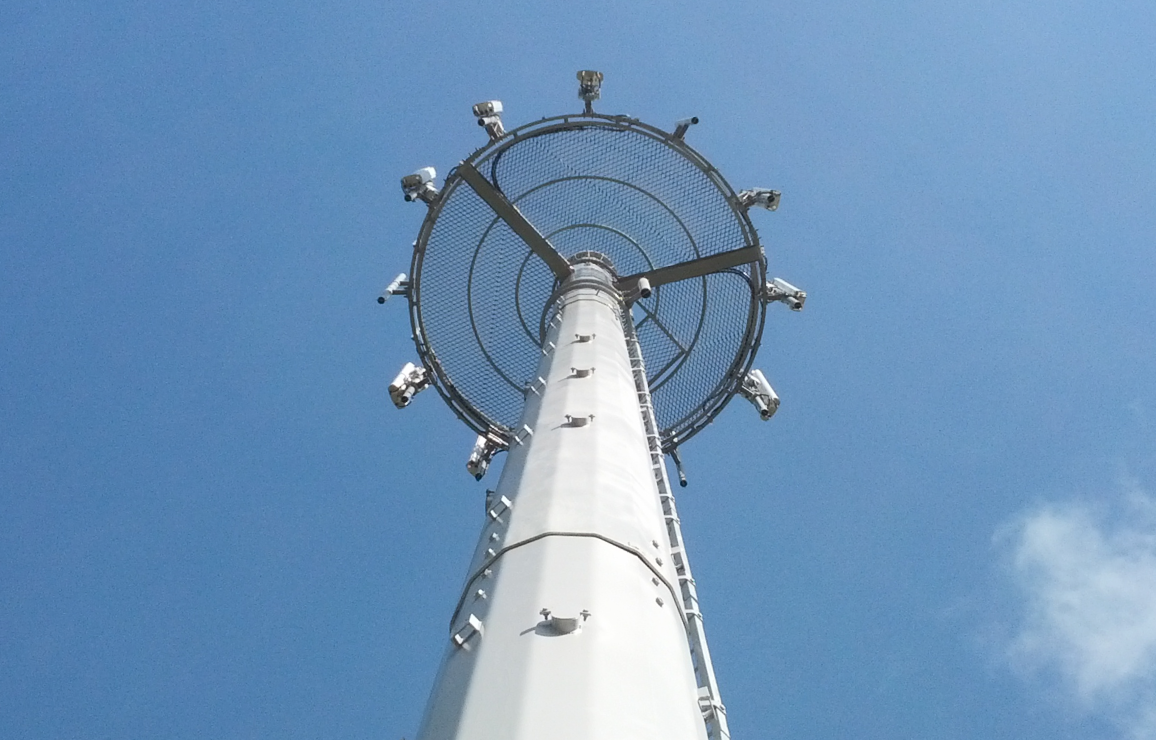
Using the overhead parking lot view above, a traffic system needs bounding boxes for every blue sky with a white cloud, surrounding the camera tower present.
[0,1,1156,740]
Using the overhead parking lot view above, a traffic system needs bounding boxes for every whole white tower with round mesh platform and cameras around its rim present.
[379,71,806,740]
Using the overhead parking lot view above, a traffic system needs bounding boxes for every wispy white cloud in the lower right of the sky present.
[1003,488,1156,740]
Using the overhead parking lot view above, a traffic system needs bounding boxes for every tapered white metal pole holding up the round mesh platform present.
[418,261,707,740]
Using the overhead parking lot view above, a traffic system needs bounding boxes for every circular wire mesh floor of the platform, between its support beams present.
[414,119,763,441]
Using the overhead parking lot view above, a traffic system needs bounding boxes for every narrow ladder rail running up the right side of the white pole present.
[622,310,731,740]
